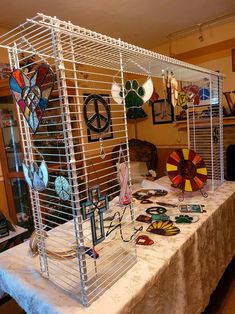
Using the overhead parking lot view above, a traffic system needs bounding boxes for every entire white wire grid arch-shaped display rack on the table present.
[0,14,223,305]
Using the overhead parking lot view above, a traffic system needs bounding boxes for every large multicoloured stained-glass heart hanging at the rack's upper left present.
[9,63,55,134]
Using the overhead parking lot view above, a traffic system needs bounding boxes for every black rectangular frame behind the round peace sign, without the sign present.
[83,93,113,143]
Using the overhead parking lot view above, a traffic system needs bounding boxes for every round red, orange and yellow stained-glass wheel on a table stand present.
[166,148,207,192]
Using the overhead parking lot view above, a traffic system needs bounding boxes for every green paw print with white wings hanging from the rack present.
[111,78,153,119]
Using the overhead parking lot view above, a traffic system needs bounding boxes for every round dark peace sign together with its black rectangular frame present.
[83,94,113,142]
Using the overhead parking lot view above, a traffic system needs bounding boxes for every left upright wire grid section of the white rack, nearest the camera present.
[4,17,136,305]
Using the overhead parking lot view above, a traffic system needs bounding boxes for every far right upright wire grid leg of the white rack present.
[187,75,224,191]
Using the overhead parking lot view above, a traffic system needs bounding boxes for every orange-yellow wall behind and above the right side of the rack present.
[129,20,235,148]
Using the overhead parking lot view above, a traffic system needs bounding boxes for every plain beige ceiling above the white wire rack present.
[0,0,235,48]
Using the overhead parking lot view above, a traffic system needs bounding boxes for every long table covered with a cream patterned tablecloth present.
[0,182,235,314]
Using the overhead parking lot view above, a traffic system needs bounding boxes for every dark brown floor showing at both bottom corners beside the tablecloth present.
[0,258,235,314]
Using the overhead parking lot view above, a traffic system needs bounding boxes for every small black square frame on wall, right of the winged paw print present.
[152,99,174,124]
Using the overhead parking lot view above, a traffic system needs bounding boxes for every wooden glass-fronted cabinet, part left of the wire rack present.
[0,80,33,230]
